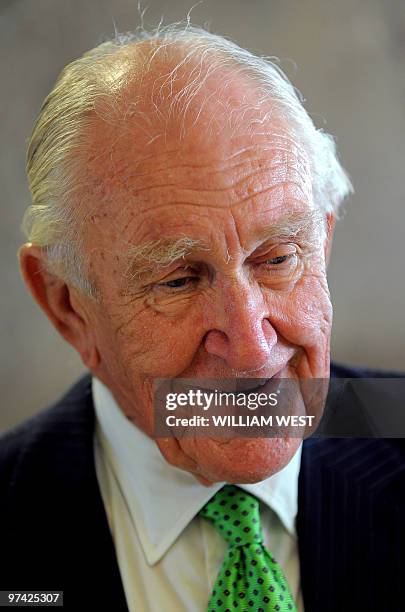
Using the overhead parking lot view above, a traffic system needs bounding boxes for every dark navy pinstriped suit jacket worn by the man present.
[0,366,405,612]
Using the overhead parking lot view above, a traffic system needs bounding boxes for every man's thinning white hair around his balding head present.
[22,22,352,297]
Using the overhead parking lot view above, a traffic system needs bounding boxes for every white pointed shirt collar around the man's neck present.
[92,377,302,565]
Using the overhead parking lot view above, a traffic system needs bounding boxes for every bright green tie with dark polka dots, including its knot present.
[200,485,297,612]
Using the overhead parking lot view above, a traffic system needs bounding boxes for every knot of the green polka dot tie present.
[200,485,263,546]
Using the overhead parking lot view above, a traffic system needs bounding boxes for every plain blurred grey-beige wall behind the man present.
[0,0,405,430]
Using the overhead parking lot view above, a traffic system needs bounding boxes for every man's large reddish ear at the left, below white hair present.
[18,242,100,368]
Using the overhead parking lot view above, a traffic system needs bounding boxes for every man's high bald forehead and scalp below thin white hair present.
[81,51,309,198]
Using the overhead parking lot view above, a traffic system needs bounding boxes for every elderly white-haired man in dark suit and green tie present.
[0,27,404,612]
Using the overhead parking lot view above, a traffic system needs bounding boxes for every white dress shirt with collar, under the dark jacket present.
[92,377,303,612]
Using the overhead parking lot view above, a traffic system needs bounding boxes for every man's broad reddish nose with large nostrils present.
[205,283,277,376]
